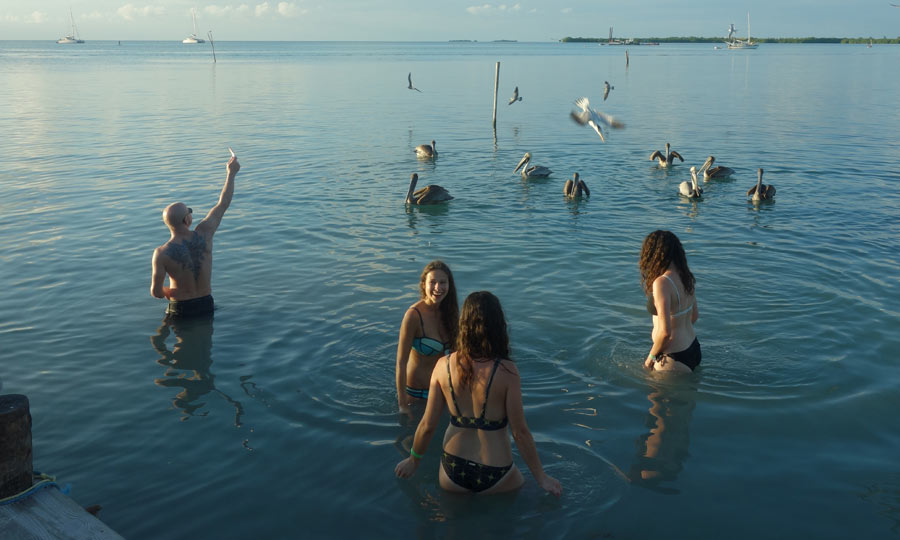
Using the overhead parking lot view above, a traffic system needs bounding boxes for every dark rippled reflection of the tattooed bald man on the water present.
[150,315,244,427]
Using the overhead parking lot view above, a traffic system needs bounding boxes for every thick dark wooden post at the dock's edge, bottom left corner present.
[0,394,34,499]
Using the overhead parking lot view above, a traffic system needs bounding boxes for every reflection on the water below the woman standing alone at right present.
[628,381,696,493]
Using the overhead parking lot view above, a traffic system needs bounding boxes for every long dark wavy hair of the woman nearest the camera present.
[456,291,509,386]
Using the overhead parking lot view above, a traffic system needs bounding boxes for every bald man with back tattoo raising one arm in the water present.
[150,157,241,317]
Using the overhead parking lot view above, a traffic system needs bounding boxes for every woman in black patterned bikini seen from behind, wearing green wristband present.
[394,291,562,496]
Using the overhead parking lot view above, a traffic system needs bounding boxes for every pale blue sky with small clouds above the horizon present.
[0,0,900,41]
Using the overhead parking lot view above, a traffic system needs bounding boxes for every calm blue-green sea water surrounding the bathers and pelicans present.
[0,42,900,539]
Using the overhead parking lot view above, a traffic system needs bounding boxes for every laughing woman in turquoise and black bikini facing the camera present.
[395,261,459,414]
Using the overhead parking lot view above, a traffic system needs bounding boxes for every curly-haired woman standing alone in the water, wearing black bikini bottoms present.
[639,231,700,373]
